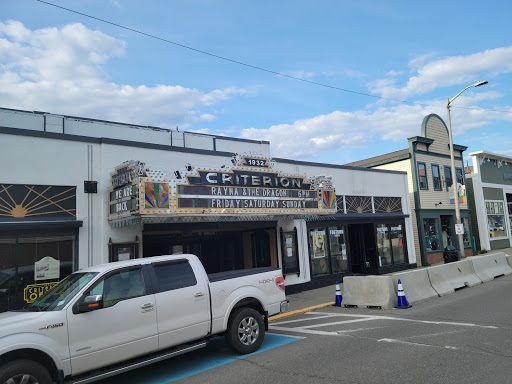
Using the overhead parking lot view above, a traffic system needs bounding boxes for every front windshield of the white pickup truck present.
[24,272,98,311]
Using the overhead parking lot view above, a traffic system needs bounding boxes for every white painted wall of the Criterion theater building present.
[0,109,416,300]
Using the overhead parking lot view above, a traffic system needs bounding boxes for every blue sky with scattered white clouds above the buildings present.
[0,0,512,164]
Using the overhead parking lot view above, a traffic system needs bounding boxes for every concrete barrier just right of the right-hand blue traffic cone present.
[392,269,438,304]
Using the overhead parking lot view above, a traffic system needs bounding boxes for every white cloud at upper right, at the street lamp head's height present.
[369,46,512,99]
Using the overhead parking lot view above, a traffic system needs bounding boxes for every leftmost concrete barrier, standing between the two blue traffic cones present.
[343,276,398,309]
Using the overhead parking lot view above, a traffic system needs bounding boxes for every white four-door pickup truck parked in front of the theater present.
[0,255,288,384]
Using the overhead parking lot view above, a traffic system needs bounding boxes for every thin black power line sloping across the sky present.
[35,0,512,113]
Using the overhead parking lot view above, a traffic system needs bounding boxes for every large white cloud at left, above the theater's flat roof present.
[0,21,245,128]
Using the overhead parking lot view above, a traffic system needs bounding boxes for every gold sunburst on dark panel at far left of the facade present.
[0,184,76,220]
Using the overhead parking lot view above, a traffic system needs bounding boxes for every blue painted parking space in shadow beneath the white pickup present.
[97,334,300,384]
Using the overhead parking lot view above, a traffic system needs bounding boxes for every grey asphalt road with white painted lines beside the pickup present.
[171,276,512,384]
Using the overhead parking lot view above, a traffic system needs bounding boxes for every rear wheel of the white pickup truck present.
[226,307,265,355]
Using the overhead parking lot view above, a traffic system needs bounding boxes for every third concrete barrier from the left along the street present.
[427,260,482,296]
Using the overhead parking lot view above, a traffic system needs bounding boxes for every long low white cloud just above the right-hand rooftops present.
[241,92,512,160]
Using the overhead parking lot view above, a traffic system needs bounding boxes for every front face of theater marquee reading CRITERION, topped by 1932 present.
[139,155,336,215]
